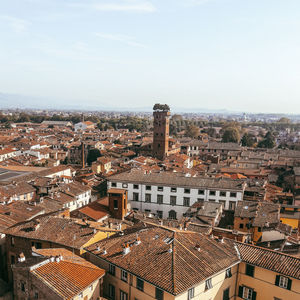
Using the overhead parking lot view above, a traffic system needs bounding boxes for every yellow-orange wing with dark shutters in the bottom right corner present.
[236,243,300,300]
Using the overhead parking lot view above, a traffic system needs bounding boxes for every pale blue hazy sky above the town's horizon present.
[0,0,300,113]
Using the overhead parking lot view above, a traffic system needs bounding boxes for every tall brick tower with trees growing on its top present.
[153,104,170,160]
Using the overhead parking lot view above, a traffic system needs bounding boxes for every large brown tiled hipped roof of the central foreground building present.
[86,223,239,295]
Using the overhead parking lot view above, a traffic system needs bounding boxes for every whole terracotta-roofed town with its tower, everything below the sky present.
[0,103,300,300]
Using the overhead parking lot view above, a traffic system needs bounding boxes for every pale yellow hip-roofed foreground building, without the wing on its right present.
[86,224,240,300]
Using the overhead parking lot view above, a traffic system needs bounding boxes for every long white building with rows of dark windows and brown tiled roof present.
[108,173,245,219]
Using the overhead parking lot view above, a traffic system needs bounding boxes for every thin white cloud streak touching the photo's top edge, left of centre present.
[70,0,156,13]
